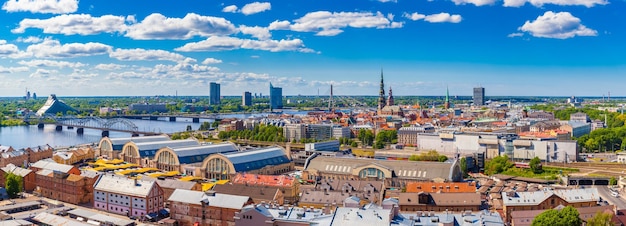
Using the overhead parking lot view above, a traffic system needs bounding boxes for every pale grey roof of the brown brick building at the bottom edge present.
[168,189,250,210]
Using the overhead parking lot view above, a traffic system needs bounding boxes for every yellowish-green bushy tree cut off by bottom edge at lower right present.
[531,206,583,226]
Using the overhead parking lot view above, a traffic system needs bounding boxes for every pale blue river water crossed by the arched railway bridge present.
[0,112,306,149]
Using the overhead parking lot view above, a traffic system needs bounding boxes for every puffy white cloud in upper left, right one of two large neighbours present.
[126,13,237,40]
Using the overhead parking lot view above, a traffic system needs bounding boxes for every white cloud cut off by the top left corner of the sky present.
[2,0,78,14]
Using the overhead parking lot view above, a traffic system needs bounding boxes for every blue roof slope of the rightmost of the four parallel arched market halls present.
[224,147,291,172]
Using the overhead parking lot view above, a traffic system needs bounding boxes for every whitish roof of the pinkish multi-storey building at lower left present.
[94,174,156,197]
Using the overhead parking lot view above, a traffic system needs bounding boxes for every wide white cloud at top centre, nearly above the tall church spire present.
[269,11,402,36]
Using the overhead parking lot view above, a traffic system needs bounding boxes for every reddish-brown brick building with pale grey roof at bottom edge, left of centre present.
[168,189,252,226]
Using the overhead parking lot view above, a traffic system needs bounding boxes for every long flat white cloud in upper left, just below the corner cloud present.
[11,14,126,35]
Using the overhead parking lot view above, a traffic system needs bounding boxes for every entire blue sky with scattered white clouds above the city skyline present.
[0,0,626,96]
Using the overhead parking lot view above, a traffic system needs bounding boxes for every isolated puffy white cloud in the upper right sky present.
[518,11,598,39]
